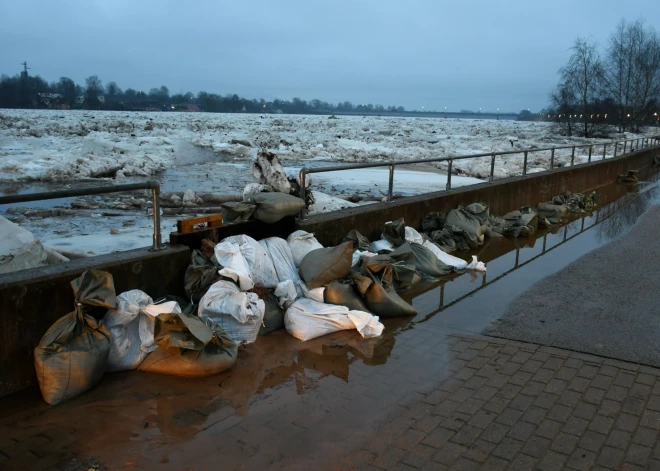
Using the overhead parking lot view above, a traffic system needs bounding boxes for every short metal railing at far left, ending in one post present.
[0,181,164,250]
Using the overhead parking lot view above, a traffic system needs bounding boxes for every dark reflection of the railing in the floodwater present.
[415,183,660,324]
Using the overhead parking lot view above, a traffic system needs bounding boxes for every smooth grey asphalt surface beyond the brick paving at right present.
[485,181,660,366]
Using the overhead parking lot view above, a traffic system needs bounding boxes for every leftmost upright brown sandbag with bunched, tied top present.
[34,270,117,405]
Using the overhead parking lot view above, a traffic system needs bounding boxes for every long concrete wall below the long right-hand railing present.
[296,149,660,245]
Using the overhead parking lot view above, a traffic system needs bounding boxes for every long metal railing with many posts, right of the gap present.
[299,136,660,219]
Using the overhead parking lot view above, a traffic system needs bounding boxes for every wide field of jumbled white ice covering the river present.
[0,110,648,182]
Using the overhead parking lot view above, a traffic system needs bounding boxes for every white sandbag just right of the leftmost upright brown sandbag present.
[102,289,153,371]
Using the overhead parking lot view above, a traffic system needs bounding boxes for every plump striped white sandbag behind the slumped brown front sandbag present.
[197,280,266,344]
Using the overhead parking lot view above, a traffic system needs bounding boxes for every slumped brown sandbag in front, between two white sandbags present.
[139,313,238,378]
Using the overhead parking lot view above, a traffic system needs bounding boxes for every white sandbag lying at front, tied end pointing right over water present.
[284,298,383,342]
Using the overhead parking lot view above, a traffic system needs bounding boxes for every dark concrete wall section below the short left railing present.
[0,246,190,397]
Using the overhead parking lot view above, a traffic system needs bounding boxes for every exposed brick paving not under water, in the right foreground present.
[342,337,660,471]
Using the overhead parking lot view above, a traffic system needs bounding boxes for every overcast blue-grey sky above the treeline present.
[0,0,660,111]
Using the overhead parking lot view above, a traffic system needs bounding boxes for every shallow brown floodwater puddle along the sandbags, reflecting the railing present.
[0,178,660,470]
